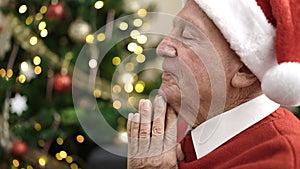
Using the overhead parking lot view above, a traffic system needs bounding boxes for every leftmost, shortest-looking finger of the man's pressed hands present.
[128,113,140,158]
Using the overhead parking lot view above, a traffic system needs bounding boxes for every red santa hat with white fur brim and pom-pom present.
[186,0,300,106]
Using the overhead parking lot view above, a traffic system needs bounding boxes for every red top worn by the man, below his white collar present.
[179,108,300,169]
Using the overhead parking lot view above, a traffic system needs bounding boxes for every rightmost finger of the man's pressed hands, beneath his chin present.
[164,106,177,152]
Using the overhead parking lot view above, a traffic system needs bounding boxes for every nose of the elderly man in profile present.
[156,37,177,57]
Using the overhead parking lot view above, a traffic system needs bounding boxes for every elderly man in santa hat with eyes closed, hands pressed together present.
[127,0,300,169]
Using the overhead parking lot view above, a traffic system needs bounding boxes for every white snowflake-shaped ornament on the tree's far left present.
[10,93,28,116]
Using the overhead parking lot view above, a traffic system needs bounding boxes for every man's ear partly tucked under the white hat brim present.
[231,65,258,88]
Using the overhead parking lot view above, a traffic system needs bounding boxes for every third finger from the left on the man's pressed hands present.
[149,96,167,156]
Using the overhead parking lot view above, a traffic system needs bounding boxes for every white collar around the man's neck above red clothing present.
[191,95,280,159]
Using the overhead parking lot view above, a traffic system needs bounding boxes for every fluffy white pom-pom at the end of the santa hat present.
[262,62,300,106]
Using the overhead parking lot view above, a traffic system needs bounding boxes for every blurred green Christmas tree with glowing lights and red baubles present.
[0,0,160,169]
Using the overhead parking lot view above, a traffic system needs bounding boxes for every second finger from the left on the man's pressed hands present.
[139,100,152,157]
